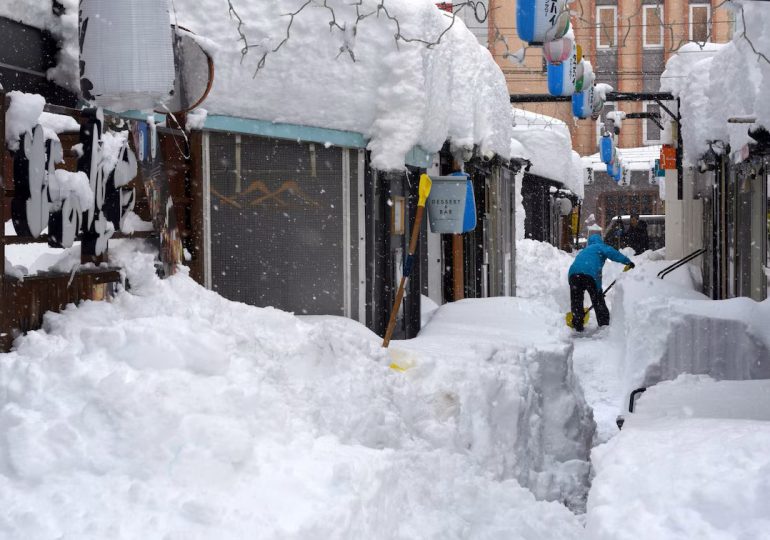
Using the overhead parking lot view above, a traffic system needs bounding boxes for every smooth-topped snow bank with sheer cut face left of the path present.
[396,298,595,509]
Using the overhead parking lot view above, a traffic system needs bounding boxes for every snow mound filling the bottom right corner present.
[586,377,770,540]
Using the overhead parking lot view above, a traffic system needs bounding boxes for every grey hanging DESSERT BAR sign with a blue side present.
[427,174,476,234]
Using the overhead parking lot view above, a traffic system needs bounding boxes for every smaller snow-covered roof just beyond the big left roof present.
[511,108,583,197]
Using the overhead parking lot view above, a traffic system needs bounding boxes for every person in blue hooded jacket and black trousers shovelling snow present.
[569,234,634,332]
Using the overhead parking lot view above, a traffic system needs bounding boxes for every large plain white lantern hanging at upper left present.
[80,0,174,112]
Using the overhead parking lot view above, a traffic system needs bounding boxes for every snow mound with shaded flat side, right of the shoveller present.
[613,261,770,392]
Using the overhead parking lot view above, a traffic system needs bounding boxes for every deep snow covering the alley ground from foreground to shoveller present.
[0,237,770,540]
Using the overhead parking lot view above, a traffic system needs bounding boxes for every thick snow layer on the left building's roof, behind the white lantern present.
[0,0,512,169]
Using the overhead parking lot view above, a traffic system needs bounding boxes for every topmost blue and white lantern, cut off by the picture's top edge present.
[516,0,569,45]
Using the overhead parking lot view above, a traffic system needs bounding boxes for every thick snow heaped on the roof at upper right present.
[661,1,770,164]
